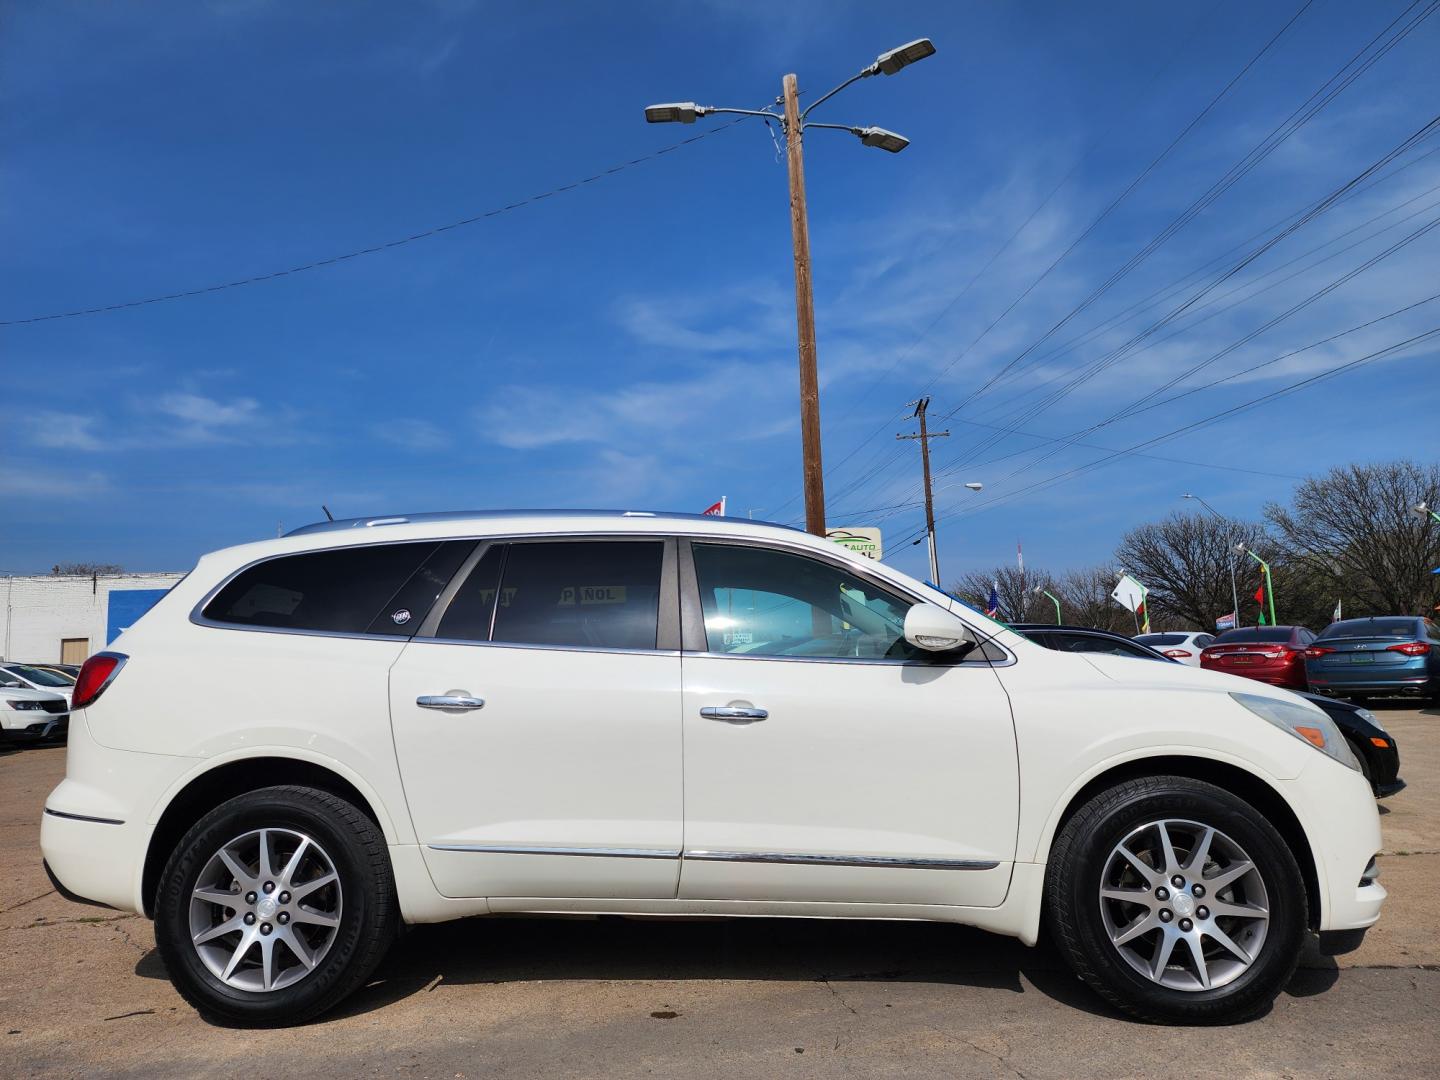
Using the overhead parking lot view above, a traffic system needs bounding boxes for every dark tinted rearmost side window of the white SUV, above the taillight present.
[204,540,463,636]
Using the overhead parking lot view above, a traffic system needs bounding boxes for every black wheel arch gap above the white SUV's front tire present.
[1044,755,1322,930]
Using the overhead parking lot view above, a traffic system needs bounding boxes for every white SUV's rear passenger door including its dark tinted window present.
[390,540,683,899]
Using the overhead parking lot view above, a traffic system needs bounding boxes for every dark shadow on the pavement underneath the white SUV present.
[135,916,1338,1022]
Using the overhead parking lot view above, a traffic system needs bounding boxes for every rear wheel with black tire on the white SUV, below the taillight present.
[156,786,399,1027]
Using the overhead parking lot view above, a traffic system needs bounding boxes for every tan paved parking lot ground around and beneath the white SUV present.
[0,708,1440,1080]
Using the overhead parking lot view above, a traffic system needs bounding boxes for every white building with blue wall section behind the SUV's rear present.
[0,573,184,664]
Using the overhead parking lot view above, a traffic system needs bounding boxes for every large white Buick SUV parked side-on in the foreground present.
[40,513,1385,1024]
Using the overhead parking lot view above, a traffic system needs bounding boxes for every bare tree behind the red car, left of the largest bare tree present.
[1115,513,1267,629]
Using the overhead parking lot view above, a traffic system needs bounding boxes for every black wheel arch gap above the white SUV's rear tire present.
[140,756,387,919]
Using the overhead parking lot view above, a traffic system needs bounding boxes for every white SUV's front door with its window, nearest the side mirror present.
[680,544,1020,907]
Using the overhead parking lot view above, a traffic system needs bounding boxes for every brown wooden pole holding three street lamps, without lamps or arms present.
[782,75,825,536]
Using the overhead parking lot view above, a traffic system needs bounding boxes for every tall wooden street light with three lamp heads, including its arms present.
[645,37,935,536]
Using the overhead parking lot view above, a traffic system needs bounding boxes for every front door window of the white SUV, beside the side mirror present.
[691,543,922,660]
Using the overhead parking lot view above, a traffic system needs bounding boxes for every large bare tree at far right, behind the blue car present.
[1266,461,1440,615]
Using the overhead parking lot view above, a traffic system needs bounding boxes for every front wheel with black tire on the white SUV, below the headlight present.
[1045,776,1309,1024]
